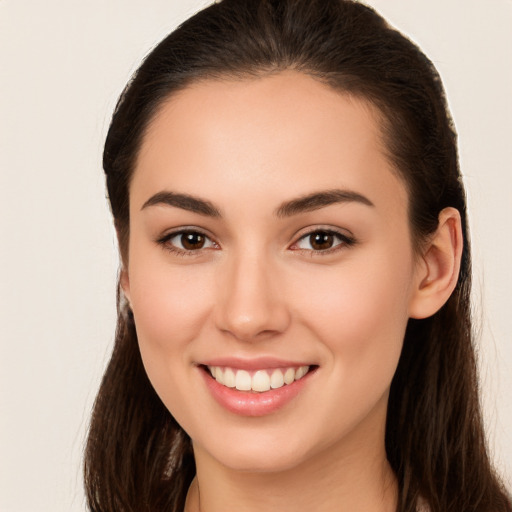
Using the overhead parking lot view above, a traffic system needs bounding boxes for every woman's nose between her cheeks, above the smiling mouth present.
[215,249,290,342]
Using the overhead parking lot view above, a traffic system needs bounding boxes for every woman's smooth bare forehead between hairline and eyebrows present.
[131,71,406,216]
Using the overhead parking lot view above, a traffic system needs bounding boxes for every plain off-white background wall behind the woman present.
[0,0,512,512]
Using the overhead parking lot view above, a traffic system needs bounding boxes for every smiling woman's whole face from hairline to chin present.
[122,72,424,471]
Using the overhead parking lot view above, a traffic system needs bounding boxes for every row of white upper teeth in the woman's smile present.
[208,366,309,393]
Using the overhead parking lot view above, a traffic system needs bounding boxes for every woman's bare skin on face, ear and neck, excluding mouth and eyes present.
[121,71,461,512]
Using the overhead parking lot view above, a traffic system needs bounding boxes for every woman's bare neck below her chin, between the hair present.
[185,402,397,512]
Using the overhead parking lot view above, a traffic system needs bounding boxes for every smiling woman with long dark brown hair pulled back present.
[85,0,511,512]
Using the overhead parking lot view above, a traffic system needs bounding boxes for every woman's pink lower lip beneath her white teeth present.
[200,368,313,416]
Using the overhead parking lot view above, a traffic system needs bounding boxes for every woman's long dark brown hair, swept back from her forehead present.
[84,0,512,512]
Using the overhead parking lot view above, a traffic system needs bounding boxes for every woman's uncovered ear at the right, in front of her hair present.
[409,207,463,319]
